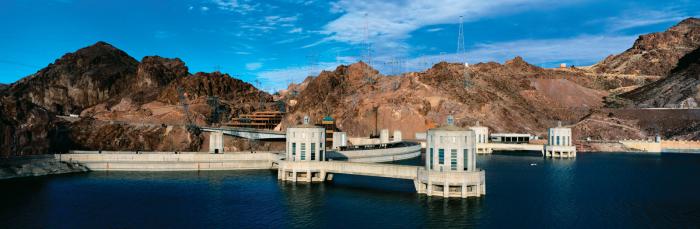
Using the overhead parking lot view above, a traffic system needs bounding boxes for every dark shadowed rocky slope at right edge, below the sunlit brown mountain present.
[621,48,700,108]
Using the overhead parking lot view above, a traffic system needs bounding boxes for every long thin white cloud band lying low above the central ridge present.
[257,35,637,91]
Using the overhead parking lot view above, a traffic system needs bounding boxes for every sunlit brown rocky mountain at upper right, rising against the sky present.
[593,18,700,76]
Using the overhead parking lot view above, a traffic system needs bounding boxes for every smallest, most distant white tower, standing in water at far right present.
[544,122,576,158]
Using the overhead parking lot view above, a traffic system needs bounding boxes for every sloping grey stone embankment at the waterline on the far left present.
[0,155,88,179]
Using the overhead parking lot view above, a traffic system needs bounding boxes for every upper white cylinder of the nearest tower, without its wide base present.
[425,116,476,171]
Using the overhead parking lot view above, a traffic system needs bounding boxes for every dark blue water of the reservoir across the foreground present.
[0,153,700,228]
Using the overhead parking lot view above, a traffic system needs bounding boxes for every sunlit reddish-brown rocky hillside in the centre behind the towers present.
[286,57,607,138]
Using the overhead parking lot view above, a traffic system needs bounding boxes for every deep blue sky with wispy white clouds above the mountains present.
[0,0,700,91]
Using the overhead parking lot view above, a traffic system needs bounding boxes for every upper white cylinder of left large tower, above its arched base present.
[286,116,326,161]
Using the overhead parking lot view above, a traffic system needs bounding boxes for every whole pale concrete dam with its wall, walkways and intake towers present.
[55,116,576,198]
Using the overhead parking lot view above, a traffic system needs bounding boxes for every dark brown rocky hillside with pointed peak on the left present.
[0,42,272,156]
